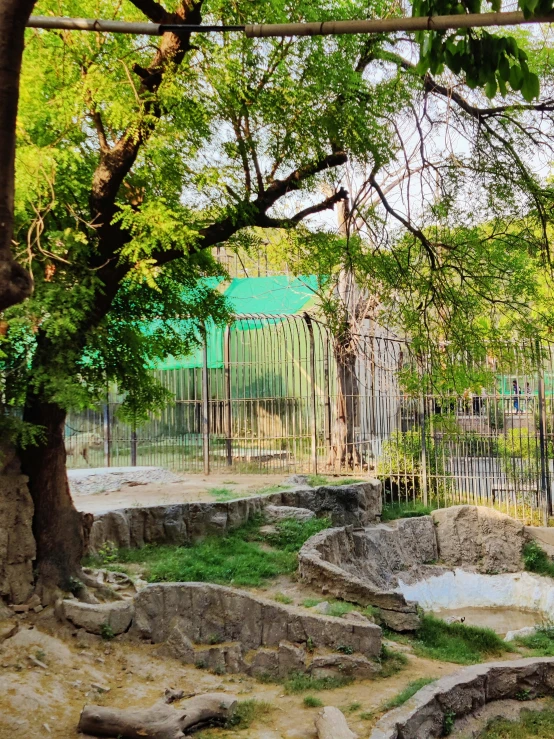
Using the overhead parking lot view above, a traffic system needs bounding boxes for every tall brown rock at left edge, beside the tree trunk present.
[0,446,36,604]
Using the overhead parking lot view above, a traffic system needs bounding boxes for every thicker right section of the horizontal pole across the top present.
[244,11,554,38]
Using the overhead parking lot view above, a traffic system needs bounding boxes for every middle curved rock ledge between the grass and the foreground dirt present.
[130,583,381,678]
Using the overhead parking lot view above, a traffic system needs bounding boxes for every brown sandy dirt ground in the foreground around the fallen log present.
[0,609,458,739]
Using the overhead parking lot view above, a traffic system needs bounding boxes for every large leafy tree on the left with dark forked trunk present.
[2,0,552,600]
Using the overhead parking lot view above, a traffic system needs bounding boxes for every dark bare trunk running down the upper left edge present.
[0,0,35,311]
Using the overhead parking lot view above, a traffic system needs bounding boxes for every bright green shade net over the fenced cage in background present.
[156,275,318,370]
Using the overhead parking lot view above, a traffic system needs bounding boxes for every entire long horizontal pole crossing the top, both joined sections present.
[27,10,554,38]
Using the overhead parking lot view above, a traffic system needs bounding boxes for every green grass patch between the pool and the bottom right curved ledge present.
[414,615,506,665]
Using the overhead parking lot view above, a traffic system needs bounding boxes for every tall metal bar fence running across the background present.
[66,314,554,523]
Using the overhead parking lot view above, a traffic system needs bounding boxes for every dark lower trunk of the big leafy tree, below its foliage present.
[21,396,86,604]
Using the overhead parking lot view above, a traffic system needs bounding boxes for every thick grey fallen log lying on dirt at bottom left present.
[78,693,237,739]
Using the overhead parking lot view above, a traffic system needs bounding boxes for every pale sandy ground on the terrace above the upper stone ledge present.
[73,472,288,513]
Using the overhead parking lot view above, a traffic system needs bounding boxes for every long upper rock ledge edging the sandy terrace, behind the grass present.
[88,480,381,554]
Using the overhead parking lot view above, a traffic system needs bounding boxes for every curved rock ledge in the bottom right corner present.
[369,657,554,739]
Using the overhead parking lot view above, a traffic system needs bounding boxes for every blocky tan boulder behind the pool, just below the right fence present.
[432,505,525,574]
